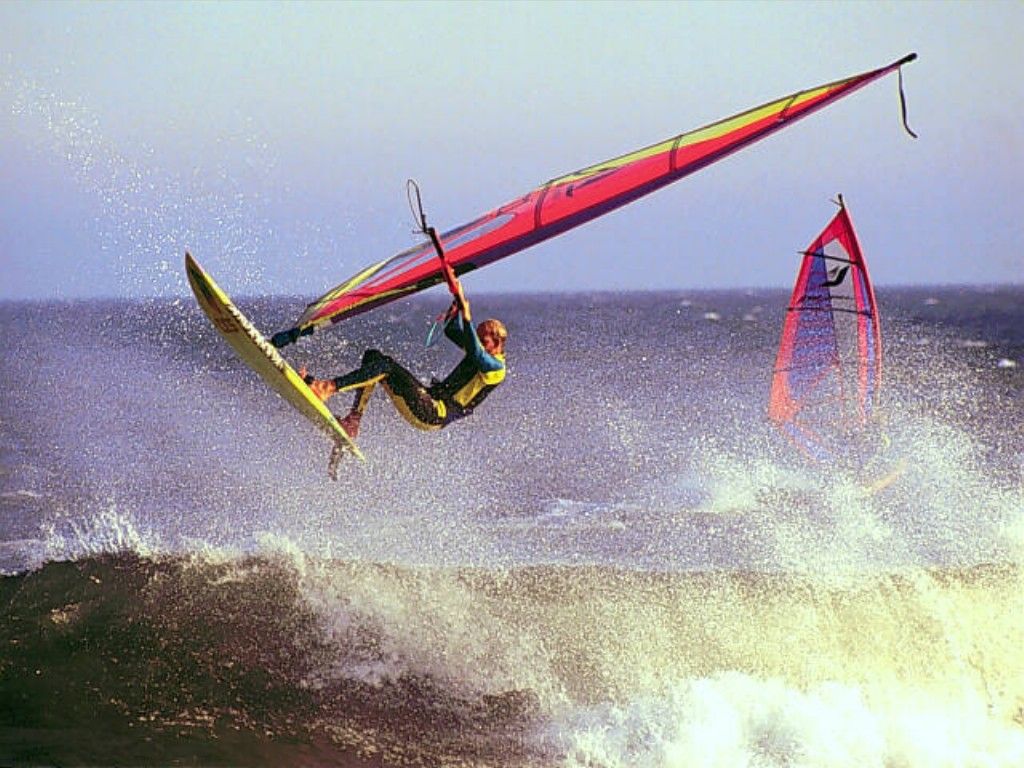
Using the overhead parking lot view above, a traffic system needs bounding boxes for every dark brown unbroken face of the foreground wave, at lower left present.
[0,555,538,766]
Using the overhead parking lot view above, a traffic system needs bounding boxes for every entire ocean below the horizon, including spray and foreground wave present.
[0,286,1024,768]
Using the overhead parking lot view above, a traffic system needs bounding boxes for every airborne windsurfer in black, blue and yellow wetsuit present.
[300,264,508,438]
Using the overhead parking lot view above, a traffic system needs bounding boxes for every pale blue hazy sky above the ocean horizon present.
[0,0,1024,299]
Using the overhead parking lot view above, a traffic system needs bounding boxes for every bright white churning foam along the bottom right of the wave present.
[538,672,1024,768]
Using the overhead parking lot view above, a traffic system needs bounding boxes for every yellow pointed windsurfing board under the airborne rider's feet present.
[185,253,364,466]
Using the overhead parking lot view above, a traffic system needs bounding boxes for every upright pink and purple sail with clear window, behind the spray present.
[768,197,882,461]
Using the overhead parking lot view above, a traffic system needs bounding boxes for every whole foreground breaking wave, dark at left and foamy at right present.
[0,554,1024,766]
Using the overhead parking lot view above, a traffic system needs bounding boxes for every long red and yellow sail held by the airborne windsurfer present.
[293,53,916,337]
